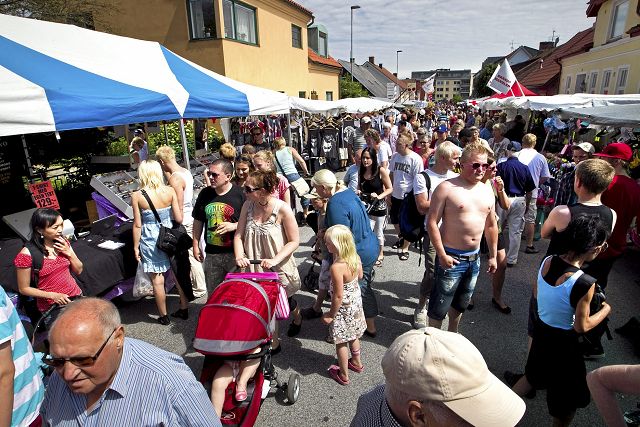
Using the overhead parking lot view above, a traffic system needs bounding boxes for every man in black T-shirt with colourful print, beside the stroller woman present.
[192,159,246,295]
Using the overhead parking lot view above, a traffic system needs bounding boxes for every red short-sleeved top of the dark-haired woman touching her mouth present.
[13,253,82,312]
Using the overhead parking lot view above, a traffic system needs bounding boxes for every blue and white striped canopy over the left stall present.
[0,14,289,136]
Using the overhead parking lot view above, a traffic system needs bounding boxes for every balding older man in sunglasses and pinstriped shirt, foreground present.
[40,298,221,427]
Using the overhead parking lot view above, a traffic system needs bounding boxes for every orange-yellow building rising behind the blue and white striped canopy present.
[96,0,340,99]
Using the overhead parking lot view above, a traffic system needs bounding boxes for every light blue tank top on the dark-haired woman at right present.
[538,257,584,330]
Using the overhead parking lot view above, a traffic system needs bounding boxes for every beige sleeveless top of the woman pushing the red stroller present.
[242,199,301,297]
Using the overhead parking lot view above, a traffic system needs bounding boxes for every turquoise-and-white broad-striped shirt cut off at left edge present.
[0,287,44,427]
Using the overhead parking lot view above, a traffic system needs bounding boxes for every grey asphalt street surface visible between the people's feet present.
[121,221,640,426]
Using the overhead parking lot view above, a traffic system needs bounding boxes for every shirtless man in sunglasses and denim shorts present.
[427,143,498,332]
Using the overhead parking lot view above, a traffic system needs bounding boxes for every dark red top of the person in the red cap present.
[598,175,640,258]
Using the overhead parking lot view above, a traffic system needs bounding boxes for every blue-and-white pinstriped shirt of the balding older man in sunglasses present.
[41,338,221,427]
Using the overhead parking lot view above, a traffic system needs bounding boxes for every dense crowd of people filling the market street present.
[0,105,640,426]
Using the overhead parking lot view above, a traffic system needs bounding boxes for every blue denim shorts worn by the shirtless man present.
[427,252,480,320]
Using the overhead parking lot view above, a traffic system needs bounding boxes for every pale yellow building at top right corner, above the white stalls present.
[559,0,640,95]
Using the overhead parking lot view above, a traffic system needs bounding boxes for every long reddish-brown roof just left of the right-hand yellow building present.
[515,27,594,91]
